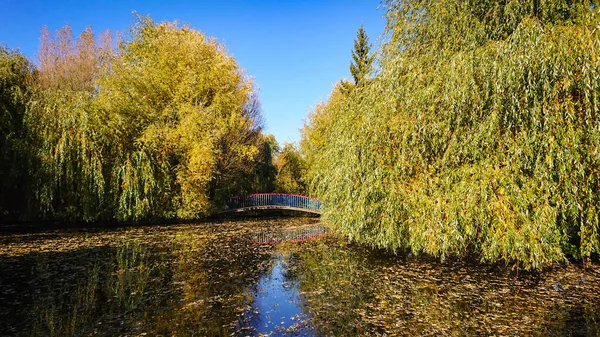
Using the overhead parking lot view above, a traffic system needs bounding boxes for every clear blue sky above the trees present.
[0,0,385,143]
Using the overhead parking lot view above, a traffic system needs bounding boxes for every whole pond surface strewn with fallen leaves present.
[0,218,600,336]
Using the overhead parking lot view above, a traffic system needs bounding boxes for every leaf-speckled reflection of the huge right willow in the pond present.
[288,240,600,336]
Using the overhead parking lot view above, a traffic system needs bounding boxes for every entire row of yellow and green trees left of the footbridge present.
[0,16,310,221]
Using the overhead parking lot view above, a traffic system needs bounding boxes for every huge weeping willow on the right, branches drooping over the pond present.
[303,0,600,269]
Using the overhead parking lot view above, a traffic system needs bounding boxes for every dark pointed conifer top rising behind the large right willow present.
[340,25,375,92]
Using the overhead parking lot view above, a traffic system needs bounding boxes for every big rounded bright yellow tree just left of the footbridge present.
[98,17,260,219]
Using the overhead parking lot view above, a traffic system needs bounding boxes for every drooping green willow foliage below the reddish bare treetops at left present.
[26,89,105,221]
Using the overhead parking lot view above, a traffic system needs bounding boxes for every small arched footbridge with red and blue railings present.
[223,193,321,214]
